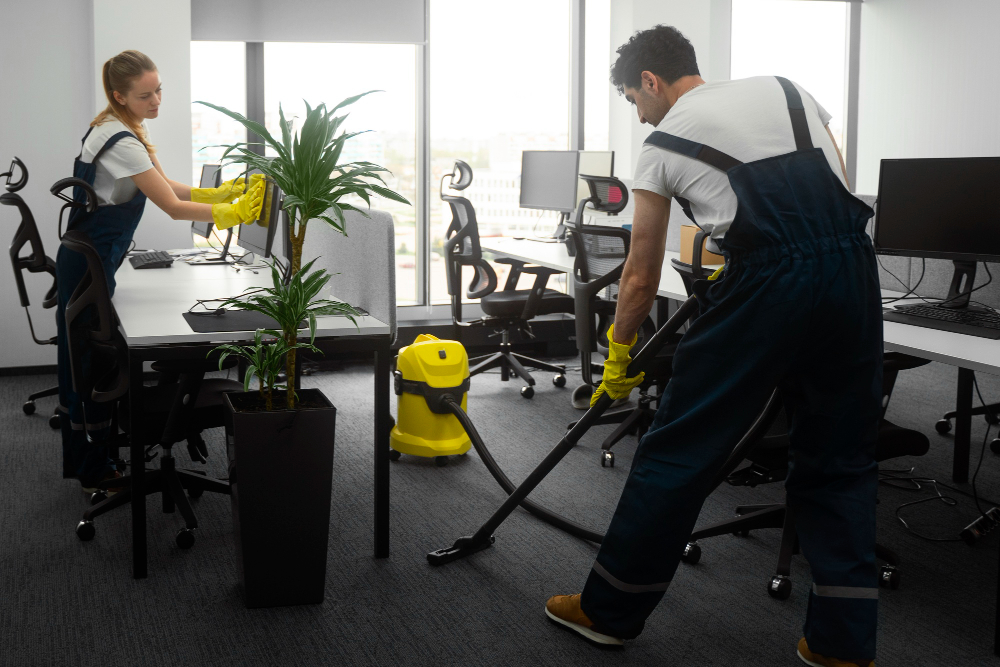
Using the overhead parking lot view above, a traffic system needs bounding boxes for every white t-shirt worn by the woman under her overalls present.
[80,120,153,206]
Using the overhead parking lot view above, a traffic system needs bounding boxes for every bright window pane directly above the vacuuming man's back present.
[732,0,849,150]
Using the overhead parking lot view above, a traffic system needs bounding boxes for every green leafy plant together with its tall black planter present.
[201,93,409,607]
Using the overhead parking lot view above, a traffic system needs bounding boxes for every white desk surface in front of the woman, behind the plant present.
[114,261,389,347]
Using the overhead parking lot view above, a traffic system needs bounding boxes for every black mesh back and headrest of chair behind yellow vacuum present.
[441,160,497,322]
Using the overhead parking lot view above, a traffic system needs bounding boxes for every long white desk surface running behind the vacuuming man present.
[481,238,1000,375]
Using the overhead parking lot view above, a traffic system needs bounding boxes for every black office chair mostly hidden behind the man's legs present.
[671,231,930,600]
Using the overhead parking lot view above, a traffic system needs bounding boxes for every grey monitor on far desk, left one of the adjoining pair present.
[520,151,580,213]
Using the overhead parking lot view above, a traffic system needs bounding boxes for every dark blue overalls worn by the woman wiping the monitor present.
[56,128,146,486]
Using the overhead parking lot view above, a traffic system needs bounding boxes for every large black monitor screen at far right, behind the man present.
[874,157,1000,262]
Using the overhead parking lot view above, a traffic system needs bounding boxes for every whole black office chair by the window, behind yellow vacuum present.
[440,160,573,398]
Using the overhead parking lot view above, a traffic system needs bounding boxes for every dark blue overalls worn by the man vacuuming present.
[582,79,882,660]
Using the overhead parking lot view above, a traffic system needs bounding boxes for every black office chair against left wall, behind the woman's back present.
[0,157,59,429]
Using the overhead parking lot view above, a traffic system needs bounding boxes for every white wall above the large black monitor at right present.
[857,0,1000,193]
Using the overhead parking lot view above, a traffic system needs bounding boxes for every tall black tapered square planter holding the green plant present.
[225,389,337,607]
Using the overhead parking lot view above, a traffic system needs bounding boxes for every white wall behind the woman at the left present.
[0,0,191,368]
